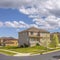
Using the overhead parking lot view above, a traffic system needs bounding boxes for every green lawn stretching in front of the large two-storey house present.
[0,46,59,54]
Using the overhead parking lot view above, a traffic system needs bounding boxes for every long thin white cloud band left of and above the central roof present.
[4,21,38,29]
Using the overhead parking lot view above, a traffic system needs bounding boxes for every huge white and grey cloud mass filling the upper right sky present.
[19,0,60,30]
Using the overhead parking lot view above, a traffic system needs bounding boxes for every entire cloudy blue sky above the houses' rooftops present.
[0,0,60,38]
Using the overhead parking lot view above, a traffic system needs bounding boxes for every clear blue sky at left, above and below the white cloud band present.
[0,8,32,37]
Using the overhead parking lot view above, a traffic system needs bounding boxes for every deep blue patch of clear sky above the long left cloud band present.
[0,8,31,23]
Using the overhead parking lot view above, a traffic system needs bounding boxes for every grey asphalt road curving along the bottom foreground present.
[0,51,60,60]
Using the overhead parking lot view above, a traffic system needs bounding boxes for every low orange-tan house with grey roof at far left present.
[0,37,18,46]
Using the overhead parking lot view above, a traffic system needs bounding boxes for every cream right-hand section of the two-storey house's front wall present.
[40,33,51,46]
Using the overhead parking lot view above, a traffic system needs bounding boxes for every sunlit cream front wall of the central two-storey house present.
[29,32,50,46]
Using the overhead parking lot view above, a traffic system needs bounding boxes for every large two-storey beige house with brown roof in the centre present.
[18,27,50,46]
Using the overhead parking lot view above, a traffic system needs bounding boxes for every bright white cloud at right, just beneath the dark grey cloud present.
[33,16,60,30]
